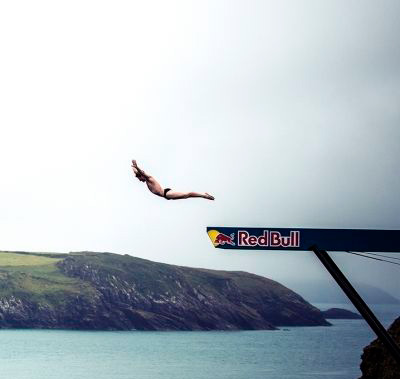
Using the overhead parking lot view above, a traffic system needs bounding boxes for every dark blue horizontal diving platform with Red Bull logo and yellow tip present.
[207,226,400,252]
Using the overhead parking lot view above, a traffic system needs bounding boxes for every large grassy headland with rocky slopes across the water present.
[0,252,336,330]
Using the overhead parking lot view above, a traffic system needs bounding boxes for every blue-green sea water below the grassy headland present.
[0,304,400,379]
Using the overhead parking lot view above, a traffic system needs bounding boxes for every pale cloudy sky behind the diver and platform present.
[0,0,400,295]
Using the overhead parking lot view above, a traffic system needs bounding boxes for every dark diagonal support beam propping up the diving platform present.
[311,246,400,365]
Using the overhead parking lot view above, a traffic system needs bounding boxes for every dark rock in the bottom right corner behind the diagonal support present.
[360,317,400,379]
